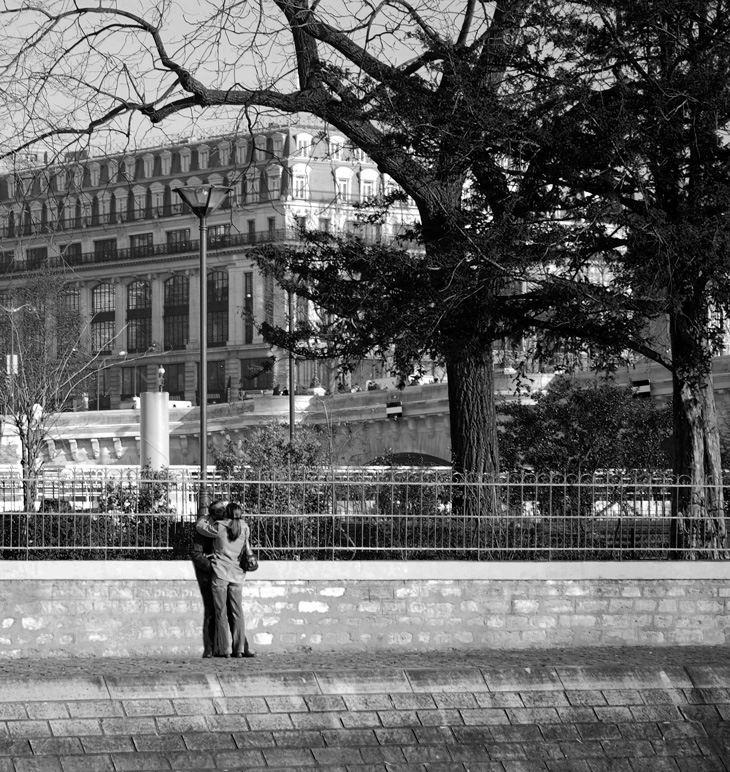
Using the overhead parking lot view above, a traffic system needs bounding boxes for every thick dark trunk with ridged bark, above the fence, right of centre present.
[446,344,499,479]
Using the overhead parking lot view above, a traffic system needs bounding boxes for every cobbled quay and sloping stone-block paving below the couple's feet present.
[0,647,730,772]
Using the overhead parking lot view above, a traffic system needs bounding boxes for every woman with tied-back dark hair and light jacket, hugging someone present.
[195,502,254,657]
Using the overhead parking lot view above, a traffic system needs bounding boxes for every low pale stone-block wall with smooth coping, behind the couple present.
[0,561,730,658]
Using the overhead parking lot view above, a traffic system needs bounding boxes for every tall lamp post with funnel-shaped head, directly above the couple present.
[175,185,232,515]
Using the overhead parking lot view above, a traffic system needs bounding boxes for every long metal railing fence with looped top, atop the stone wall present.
[0,467,728,561]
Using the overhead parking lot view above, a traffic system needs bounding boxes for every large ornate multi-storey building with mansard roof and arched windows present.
[0,123,417,409]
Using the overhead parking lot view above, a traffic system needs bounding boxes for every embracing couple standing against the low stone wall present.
[192,501,255,658]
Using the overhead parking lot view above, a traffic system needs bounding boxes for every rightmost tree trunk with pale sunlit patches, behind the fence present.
[670,315,730,559]
